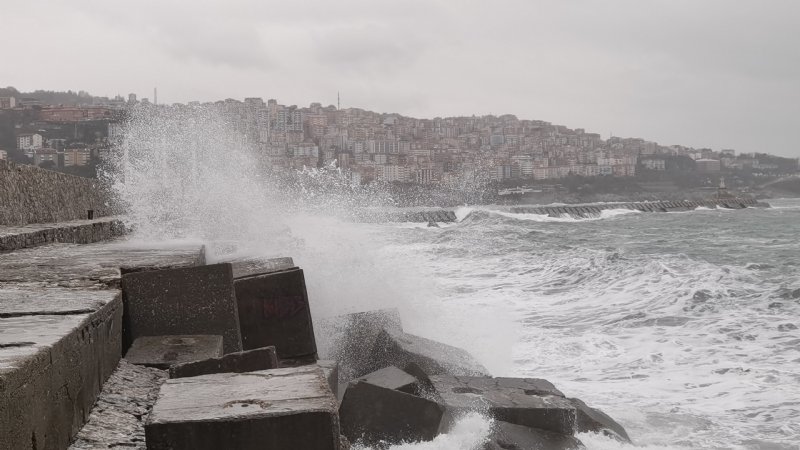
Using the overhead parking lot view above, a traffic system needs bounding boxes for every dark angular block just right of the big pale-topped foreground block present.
[339,381,444,445]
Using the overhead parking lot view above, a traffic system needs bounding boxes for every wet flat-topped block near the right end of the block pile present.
[431,375,577,435]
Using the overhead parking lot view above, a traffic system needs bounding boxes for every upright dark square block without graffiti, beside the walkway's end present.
[122,263,242,353]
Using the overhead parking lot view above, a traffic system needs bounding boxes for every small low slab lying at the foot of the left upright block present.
[125,334,222,369]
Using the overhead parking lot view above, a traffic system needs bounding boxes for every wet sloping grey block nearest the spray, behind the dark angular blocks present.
[371,330,489,376]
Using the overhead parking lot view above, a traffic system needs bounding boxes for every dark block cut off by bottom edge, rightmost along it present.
[482,421,584,450]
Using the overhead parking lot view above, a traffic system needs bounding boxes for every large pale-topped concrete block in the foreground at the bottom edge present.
[145,366,341,450]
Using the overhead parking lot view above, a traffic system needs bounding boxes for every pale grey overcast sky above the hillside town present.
[0,0,800,157]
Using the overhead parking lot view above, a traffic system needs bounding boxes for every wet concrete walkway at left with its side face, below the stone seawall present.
[0,240,204,449]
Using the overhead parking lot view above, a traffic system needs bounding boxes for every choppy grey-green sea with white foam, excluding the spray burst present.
[338,199,800,449]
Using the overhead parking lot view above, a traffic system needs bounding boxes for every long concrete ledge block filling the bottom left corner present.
[0,297,122,449]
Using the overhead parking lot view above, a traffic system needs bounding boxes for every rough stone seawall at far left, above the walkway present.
[0,161,110,225]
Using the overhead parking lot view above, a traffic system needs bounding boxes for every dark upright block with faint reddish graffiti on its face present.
[234,268,317,359]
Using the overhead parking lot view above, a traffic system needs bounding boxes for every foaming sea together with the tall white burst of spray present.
[105,108,800,450]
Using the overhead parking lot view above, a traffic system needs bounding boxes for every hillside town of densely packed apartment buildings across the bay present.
[0,89,798,185]
